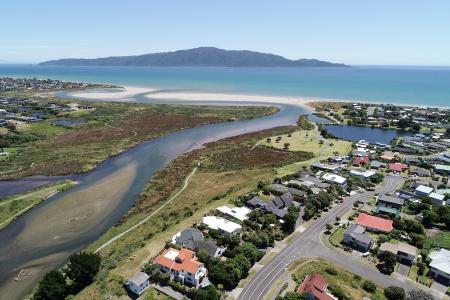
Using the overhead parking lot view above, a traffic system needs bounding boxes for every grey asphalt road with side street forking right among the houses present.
[238,175,414,300]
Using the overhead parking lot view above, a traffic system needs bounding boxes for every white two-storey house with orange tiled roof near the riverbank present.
[154,248,207,288]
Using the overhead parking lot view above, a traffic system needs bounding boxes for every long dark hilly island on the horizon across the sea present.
[39,47,349,67]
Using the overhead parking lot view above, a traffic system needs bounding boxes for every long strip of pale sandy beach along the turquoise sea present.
[68,85,450,109]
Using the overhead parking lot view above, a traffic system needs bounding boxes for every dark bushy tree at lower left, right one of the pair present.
[66,252,101,291]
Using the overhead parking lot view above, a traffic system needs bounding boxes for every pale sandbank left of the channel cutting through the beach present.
[70,86,154,100]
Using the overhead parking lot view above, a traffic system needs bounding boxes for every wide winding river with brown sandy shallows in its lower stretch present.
[0,88,308,299]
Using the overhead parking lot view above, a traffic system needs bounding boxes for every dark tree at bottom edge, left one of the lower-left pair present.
[33,270,67,300]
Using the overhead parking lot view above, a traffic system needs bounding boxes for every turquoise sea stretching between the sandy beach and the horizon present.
[0,65,450,107]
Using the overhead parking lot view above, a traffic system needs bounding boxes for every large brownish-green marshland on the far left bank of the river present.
[0,98,277,179]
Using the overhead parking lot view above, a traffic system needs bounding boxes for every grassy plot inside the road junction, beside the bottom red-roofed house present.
[294,259,386,300]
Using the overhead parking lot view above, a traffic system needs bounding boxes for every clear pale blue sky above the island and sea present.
[0,0,450,66]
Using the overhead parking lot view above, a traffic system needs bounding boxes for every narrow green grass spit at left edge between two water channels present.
[0,180,75,229]
